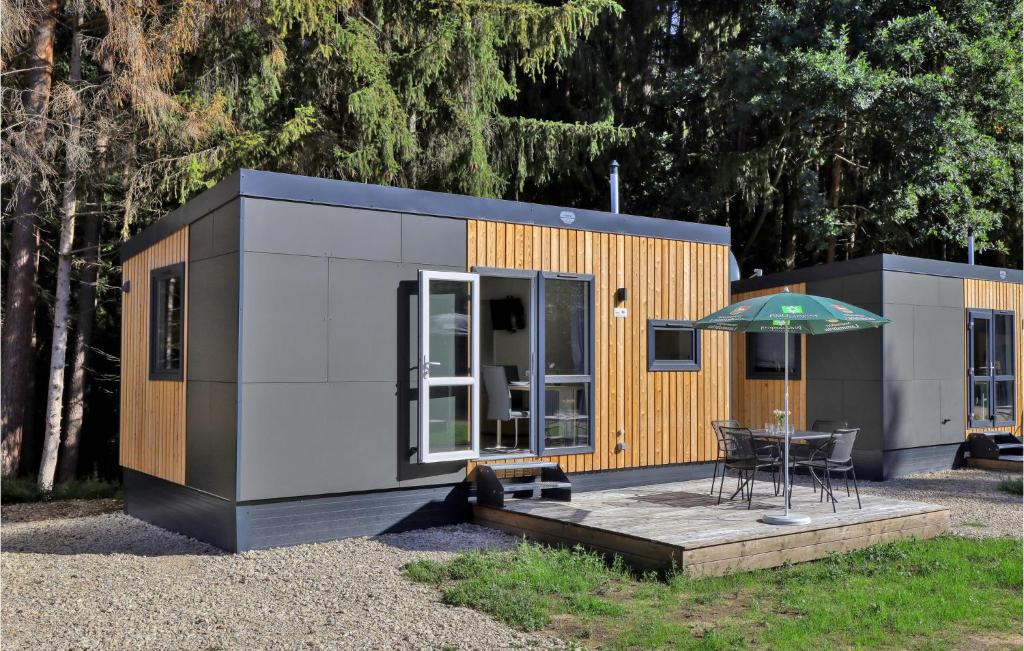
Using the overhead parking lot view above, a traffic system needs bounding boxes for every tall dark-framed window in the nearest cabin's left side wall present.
[150,262,185,380]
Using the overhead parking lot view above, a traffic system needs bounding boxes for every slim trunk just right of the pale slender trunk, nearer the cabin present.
[57,206,99,482]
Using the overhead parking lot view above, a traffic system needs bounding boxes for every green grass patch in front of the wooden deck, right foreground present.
[407,537,1022,649]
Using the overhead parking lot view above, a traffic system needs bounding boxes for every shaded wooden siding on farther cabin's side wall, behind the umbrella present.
[731,283,807,430]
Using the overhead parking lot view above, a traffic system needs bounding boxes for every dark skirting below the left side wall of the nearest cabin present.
[123,468,239,552]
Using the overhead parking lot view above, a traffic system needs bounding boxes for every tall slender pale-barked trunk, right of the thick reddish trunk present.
[39,6,82,490]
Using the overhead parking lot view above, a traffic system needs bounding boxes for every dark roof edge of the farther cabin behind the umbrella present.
[732,253,1024,294]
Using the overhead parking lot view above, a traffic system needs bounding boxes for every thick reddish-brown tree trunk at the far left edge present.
[0,0,57,474]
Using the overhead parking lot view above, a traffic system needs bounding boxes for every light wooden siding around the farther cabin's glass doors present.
[964,278,1024,436]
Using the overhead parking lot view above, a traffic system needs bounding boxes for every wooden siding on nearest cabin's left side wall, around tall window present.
[120,226,188,484]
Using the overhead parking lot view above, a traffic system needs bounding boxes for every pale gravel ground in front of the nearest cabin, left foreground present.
[0,514,561,650]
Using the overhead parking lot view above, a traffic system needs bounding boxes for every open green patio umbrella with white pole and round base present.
[694,288,889,524]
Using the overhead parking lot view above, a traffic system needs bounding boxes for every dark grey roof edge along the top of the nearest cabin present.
[121,170,730,260]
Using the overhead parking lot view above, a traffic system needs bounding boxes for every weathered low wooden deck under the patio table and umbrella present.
[473,479,949,576]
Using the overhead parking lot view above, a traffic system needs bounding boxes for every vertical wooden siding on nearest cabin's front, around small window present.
[467,220,730,473]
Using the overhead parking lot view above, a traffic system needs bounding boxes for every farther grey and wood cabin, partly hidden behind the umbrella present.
[732,255,1024,479]
